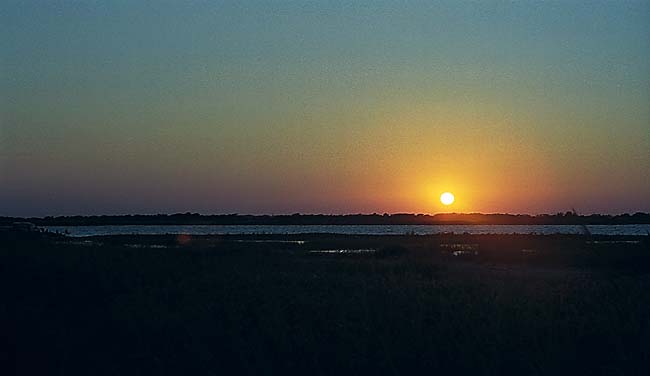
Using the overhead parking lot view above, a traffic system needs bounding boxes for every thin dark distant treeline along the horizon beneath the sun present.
[0,212,650,226]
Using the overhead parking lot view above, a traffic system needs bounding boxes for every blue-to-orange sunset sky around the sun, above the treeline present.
[0,0,650,216]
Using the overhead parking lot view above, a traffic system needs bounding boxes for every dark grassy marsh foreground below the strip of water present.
[0,234,650,375]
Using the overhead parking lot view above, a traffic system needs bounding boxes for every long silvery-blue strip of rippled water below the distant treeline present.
[46,225,650,236]
